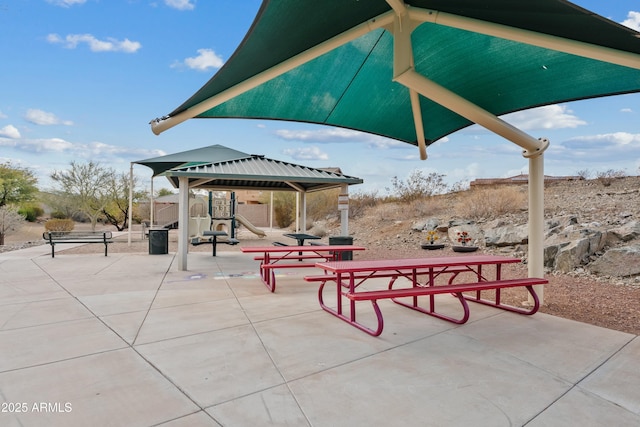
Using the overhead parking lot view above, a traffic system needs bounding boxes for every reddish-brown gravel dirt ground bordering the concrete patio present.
[0,224,640,335]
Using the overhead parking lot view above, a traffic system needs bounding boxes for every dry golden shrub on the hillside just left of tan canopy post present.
[455,186,527,219]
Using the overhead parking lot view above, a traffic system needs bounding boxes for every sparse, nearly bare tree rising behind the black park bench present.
[51,161,113,230]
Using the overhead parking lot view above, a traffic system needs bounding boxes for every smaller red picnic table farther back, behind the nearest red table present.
[241,245,366,292]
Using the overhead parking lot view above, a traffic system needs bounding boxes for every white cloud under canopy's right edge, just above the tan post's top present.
[502,104,587,130]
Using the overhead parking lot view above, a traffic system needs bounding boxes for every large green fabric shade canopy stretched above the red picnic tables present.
[151,0,640,155]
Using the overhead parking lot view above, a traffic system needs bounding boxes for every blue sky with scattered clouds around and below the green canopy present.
[0,0,640,193]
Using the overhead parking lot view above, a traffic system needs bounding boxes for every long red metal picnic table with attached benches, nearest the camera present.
[304,255,548,336]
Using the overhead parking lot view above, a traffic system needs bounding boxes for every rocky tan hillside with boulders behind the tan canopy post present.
[326,176,640,284]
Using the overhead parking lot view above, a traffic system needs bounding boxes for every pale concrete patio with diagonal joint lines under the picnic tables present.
[0,246,640,427]
